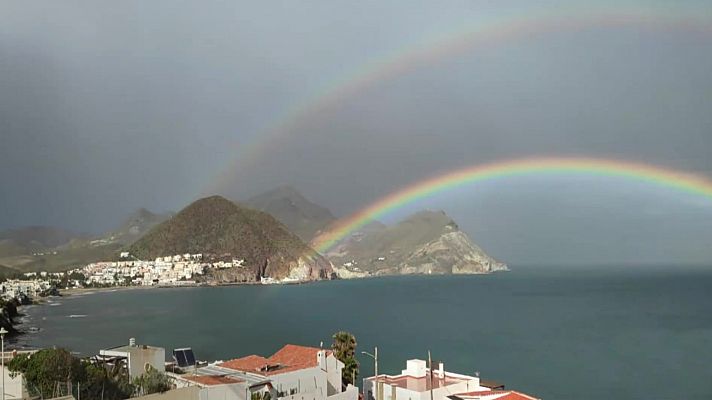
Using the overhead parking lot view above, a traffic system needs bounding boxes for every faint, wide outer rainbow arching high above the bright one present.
[207,2,712,193]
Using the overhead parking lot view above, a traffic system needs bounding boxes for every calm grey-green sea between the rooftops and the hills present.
[13,267,712,400]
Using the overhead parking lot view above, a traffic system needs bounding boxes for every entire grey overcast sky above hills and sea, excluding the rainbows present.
[0,1,712,264]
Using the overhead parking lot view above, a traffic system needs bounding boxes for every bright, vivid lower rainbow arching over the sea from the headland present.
[312,157,712,253]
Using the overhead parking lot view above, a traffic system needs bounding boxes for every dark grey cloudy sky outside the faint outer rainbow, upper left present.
[0,1,490,231]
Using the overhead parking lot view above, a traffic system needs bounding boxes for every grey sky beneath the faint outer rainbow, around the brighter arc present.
[216,21,712,263]
